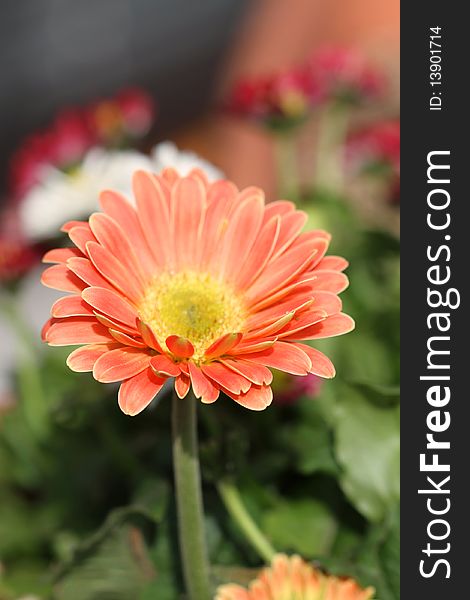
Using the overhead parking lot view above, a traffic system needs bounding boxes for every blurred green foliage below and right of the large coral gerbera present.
[0,185,399,600]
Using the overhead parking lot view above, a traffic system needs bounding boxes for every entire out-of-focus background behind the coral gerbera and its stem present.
[0,0,400,600]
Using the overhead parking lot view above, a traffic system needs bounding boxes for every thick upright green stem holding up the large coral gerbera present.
[172,391,211,600]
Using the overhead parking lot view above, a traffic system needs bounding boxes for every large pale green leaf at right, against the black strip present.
[336,386,400,521]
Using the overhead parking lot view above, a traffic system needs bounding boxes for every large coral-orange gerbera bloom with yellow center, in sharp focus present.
[42,169,354,415]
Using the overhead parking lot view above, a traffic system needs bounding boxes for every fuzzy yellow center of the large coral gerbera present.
[139,271,245,362]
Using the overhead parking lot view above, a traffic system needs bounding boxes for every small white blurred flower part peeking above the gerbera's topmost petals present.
[151,142,224,181]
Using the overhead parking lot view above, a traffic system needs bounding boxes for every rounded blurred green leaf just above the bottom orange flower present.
[262,498,337,557]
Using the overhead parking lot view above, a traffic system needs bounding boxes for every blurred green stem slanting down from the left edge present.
[0,290,49,441]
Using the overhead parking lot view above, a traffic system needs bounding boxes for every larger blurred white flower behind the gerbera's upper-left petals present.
[19,148,153,241]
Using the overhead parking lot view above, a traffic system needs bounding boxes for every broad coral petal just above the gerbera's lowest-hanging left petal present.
[93,347,150,383]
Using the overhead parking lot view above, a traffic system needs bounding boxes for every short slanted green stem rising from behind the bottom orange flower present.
[217,481,276,563]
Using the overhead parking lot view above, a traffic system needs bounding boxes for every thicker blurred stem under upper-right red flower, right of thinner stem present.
[312,103,351,195]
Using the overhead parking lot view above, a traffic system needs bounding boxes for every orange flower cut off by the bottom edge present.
[216,554,374,600]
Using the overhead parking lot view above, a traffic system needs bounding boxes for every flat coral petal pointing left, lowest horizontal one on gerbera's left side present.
[45,317,114,346]
